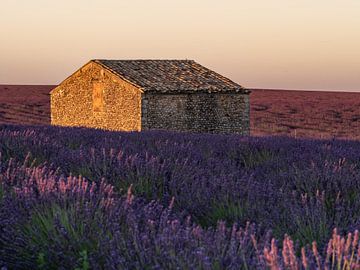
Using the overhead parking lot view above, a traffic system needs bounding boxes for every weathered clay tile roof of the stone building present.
[93,60,248,93]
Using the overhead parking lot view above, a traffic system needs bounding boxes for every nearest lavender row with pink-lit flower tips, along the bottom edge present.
[0,159,360,269]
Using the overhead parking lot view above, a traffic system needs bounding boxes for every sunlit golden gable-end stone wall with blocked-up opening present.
[51,62,141,131]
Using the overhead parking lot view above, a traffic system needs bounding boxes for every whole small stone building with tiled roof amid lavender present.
[51,60,250,135]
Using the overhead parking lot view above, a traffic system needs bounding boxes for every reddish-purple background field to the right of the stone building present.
[250,90,360,139]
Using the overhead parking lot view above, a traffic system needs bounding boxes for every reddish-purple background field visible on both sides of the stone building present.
[0,85,360,139]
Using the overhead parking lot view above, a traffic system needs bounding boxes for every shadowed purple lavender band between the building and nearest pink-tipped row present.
[0,126,360,262]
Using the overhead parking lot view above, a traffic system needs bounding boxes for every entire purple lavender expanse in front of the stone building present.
[0,125,360,269]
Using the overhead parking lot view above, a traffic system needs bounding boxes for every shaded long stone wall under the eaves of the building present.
[142,93,250,135]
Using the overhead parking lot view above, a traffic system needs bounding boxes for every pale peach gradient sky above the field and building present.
[0,0,360,90]
